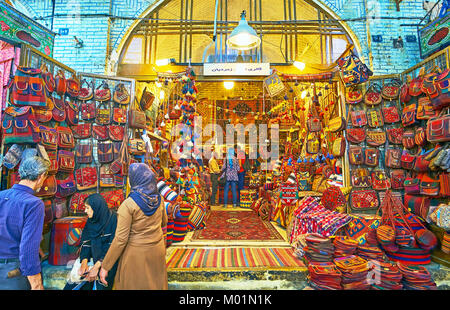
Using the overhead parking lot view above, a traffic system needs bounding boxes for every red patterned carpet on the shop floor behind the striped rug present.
[192,210,284,241]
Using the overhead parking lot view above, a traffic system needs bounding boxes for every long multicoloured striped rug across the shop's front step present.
[167,248,305,269]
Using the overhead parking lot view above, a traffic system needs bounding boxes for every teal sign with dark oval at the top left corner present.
[0,3,55,57]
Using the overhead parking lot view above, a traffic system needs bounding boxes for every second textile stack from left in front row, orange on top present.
[334,255,370,290]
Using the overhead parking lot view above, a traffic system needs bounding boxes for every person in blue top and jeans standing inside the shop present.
[219,148,240,208]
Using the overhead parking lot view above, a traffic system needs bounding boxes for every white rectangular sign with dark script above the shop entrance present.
[203,63,270,76]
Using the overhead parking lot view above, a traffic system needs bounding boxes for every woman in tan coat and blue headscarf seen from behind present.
[100,163,168,290]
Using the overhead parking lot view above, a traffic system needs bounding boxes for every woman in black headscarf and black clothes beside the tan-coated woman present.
[64,194,117,290]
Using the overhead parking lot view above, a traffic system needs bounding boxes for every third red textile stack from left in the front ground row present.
[370,262,403,290]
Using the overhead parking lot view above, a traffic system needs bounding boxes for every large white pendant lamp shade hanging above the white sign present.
[227,11,261,51]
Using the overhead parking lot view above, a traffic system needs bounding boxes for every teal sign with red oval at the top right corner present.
[419,13,450,58]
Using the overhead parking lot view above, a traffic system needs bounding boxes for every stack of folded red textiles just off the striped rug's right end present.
[304,234,334,263]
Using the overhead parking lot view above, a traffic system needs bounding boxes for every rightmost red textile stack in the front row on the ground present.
[397,263,437,290]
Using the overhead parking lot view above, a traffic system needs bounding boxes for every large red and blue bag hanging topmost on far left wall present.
[9,67,47,107]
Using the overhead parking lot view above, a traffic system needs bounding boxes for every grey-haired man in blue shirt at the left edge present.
[0,156,50,290]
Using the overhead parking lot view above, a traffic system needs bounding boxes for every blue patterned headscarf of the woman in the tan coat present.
[128,163,161,216]
